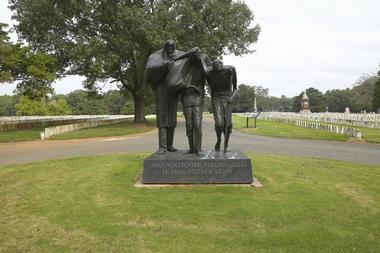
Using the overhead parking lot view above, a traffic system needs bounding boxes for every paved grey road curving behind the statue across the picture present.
[0,118,380,165]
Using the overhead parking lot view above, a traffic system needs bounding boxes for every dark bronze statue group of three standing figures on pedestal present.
[145,40,237,156]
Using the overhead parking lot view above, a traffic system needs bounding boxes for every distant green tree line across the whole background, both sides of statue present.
[0,71,380,116]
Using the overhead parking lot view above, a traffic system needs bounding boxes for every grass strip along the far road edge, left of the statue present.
[0,118,155,143]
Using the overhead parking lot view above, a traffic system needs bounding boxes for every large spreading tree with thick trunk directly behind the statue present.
[9,0,260,121]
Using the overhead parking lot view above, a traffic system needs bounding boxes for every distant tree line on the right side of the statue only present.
[227,71,380,113]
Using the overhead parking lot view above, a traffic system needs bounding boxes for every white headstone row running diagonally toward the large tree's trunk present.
[41,116,132,140]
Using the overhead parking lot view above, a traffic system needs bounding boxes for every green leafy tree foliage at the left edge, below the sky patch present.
[0,23,56,100]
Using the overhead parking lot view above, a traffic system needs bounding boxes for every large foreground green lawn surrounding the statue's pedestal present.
[0,154,380,253]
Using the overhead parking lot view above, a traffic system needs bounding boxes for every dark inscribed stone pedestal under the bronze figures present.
[142,151,253,184]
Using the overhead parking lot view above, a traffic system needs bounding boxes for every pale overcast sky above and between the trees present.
[0,0,380,96]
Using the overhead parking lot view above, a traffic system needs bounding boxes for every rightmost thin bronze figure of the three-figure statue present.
[206,59,237,152]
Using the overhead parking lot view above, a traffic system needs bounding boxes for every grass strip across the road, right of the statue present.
[233,116,349,141]
